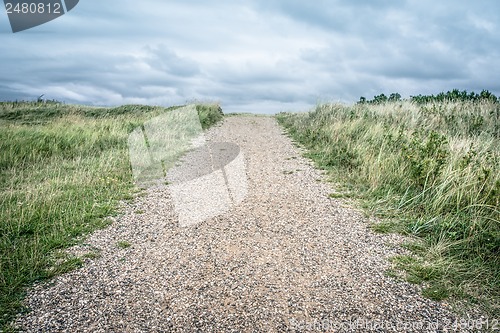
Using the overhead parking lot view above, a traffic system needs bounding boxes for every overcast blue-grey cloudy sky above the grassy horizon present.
[0,0,500,113]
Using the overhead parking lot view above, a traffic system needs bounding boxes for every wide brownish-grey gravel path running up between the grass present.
[16,116,466,332]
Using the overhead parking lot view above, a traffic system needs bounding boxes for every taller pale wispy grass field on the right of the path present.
[277,100,500,315]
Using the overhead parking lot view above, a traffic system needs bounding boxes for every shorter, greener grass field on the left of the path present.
[0,102,223,328]
